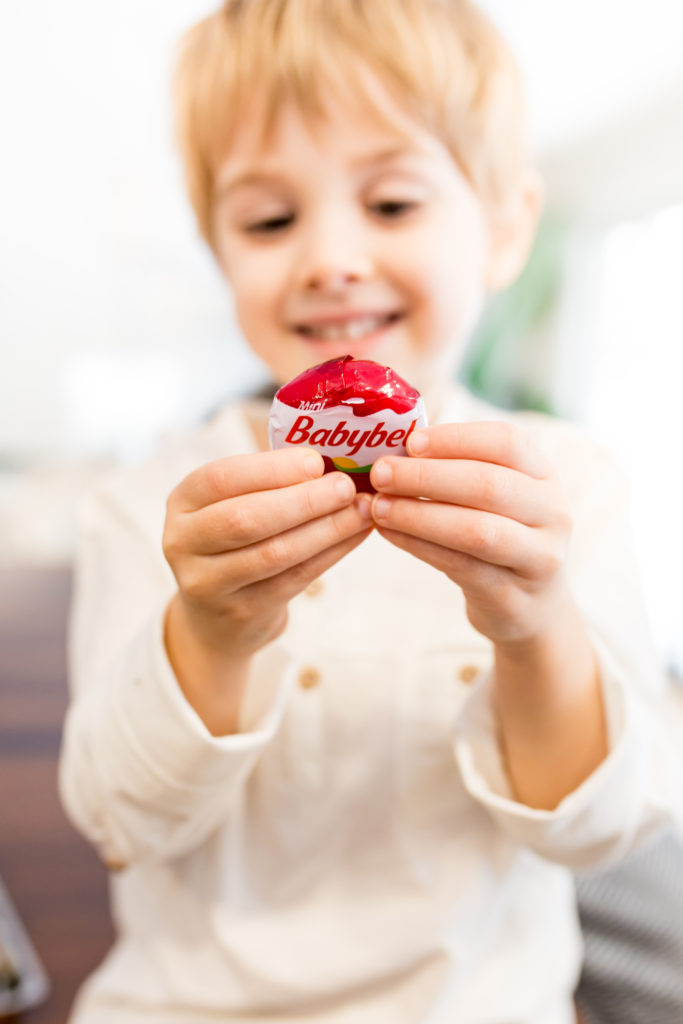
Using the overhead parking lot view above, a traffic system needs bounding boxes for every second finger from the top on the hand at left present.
[186,473,355,555]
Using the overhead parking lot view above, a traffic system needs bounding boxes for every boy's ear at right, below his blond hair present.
[485,169,545,292]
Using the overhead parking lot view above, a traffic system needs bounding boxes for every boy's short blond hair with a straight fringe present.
[175,0,527,245]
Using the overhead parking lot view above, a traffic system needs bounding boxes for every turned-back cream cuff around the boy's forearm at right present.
[454,640,660,869]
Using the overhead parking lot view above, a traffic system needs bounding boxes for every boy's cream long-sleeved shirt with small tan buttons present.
[60,390,680,1024]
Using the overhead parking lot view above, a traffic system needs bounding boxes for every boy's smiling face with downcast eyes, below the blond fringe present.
[214,80,501,403]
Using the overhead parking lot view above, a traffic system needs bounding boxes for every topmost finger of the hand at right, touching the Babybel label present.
[408,421,553,479]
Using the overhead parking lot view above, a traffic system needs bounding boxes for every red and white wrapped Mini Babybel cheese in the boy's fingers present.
[268,355,427,492]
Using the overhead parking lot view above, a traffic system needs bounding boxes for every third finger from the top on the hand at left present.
[211,496,372,590]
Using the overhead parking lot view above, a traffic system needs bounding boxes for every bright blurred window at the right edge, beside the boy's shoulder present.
[584,206,683,678]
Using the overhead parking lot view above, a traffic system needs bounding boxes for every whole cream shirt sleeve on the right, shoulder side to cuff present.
[455,436,683,869]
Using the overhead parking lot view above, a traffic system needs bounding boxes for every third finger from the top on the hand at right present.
[372,495,542,577]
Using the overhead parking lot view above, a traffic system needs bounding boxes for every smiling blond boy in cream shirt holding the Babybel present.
[61,0,676,1024]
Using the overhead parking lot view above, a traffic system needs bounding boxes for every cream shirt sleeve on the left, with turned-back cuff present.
[59,468,293,867]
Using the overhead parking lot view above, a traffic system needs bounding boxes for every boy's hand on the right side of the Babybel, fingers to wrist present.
[371,422,571,643]
